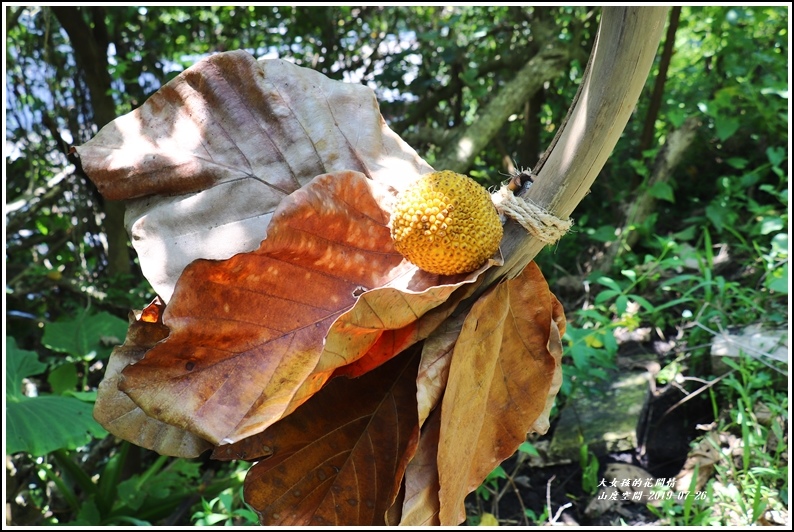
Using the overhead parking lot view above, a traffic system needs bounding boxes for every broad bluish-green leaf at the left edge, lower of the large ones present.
[6,395,107,456]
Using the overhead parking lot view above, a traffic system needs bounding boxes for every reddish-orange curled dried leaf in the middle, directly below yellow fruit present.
[120,172,485,444]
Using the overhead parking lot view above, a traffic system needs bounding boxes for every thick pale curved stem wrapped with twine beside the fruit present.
[482,7,668,286]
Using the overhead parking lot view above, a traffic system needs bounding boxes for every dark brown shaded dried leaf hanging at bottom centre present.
[213,350,419,526]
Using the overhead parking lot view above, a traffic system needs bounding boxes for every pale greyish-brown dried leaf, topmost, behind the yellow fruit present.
[75,51,432,301]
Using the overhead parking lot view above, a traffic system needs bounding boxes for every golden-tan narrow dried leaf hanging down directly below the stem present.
[438,262,559,526]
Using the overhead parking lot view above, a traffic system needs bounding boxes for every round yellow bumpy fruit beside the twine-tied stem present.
[390,170,502,275]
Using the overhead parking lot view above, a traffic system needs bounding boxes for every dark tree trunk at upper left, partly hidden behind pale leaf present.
[50,6,132,276]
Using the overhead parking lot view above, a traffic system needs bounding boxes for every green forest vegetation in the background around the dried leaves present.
[4,6,790,525]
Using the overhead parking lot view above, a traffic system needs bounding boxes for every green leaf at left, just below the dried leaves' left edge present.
[41,312,127,359]
